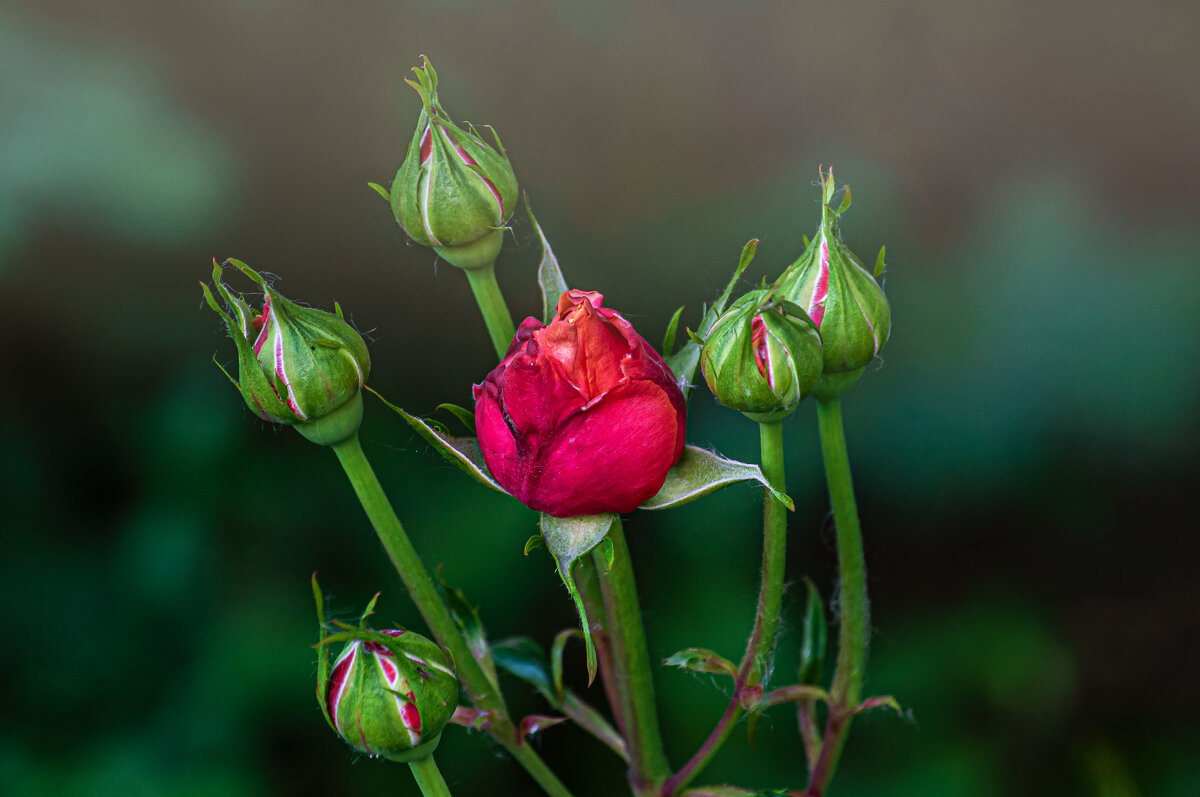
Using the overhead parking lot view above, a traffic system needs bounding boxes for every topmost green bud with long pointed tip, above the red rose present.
[391,55,517,269]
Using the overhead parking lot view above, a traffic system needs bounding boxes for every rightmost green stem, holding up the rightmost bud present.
[808,397,869,797]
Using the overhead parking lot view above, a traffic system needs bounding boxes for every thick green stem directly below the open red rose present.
[598,517,670,796]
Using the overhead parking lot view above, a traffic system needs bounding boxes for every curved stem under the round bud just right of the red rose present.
[662,421,787,797]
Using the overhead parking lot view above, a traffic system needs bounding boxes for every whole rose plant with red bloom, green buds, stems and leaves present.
[204,60,896,797]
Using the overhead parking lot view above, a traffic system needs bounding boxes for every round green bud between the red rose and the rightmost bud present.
[700,290,821,423]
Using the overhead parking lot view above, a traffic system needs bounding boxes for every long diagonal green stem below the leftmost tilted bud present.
[332,435,570,797]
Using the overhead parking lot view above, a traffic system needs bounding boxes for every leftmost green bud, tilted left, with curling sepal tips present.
[200,260,371,445]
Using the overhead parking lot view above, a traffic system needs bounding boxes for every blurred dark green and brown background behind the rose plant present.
[0,0,1200,797]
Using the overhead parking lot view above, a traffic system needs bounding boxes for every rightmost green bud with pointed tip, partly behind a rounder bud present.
[775,168,892,396]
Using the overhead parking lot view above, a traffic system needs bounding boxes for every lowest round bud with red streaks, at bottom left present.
[324,629,458,761]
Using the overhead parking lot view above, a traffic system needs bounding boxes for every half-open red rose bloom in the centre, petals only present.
[475,290,688,517]
